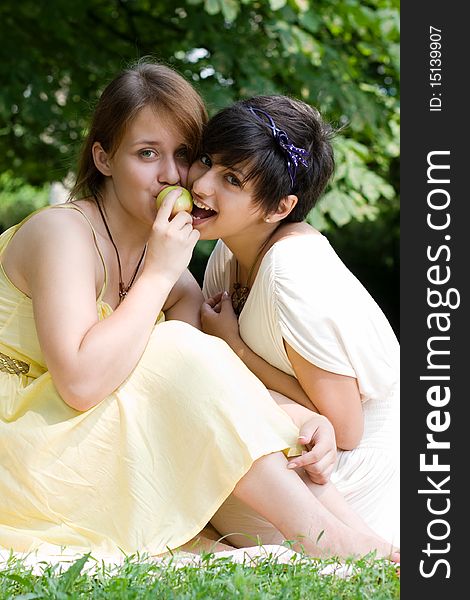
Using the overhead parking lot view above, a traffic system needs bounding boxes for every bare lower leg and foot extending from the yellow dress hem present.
[233,453,397,560]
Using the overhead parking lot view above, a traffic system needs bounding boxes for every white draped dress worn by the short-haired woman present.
[203,234,400,546]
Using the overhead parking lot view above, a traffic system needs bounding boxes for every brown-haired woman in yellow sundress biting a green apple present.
[0,63,396,556]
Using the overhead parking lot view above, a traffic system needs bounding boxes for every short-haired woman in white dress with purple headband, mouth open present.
[189,96,399,545]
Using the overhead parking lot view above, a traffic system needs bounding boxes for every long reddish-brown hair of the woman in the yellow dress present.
[69,59,207,199]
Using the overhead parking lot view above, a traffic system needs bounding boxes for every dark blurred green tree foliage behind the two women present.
[0,0,399,333]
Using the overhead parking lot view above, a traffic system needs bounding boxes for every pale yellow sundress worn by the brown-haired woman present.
[0,204,298,556]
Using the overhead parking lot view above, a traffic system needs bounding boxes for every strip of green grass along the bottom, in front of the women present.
[0,554,400,600]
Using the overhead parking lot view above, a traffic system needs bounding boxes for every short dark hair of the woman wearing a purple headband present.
[202,95,335,222]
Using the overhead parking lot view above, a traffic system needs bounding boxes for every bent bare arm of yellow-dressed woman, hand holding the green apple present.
[17,194,199,410]
